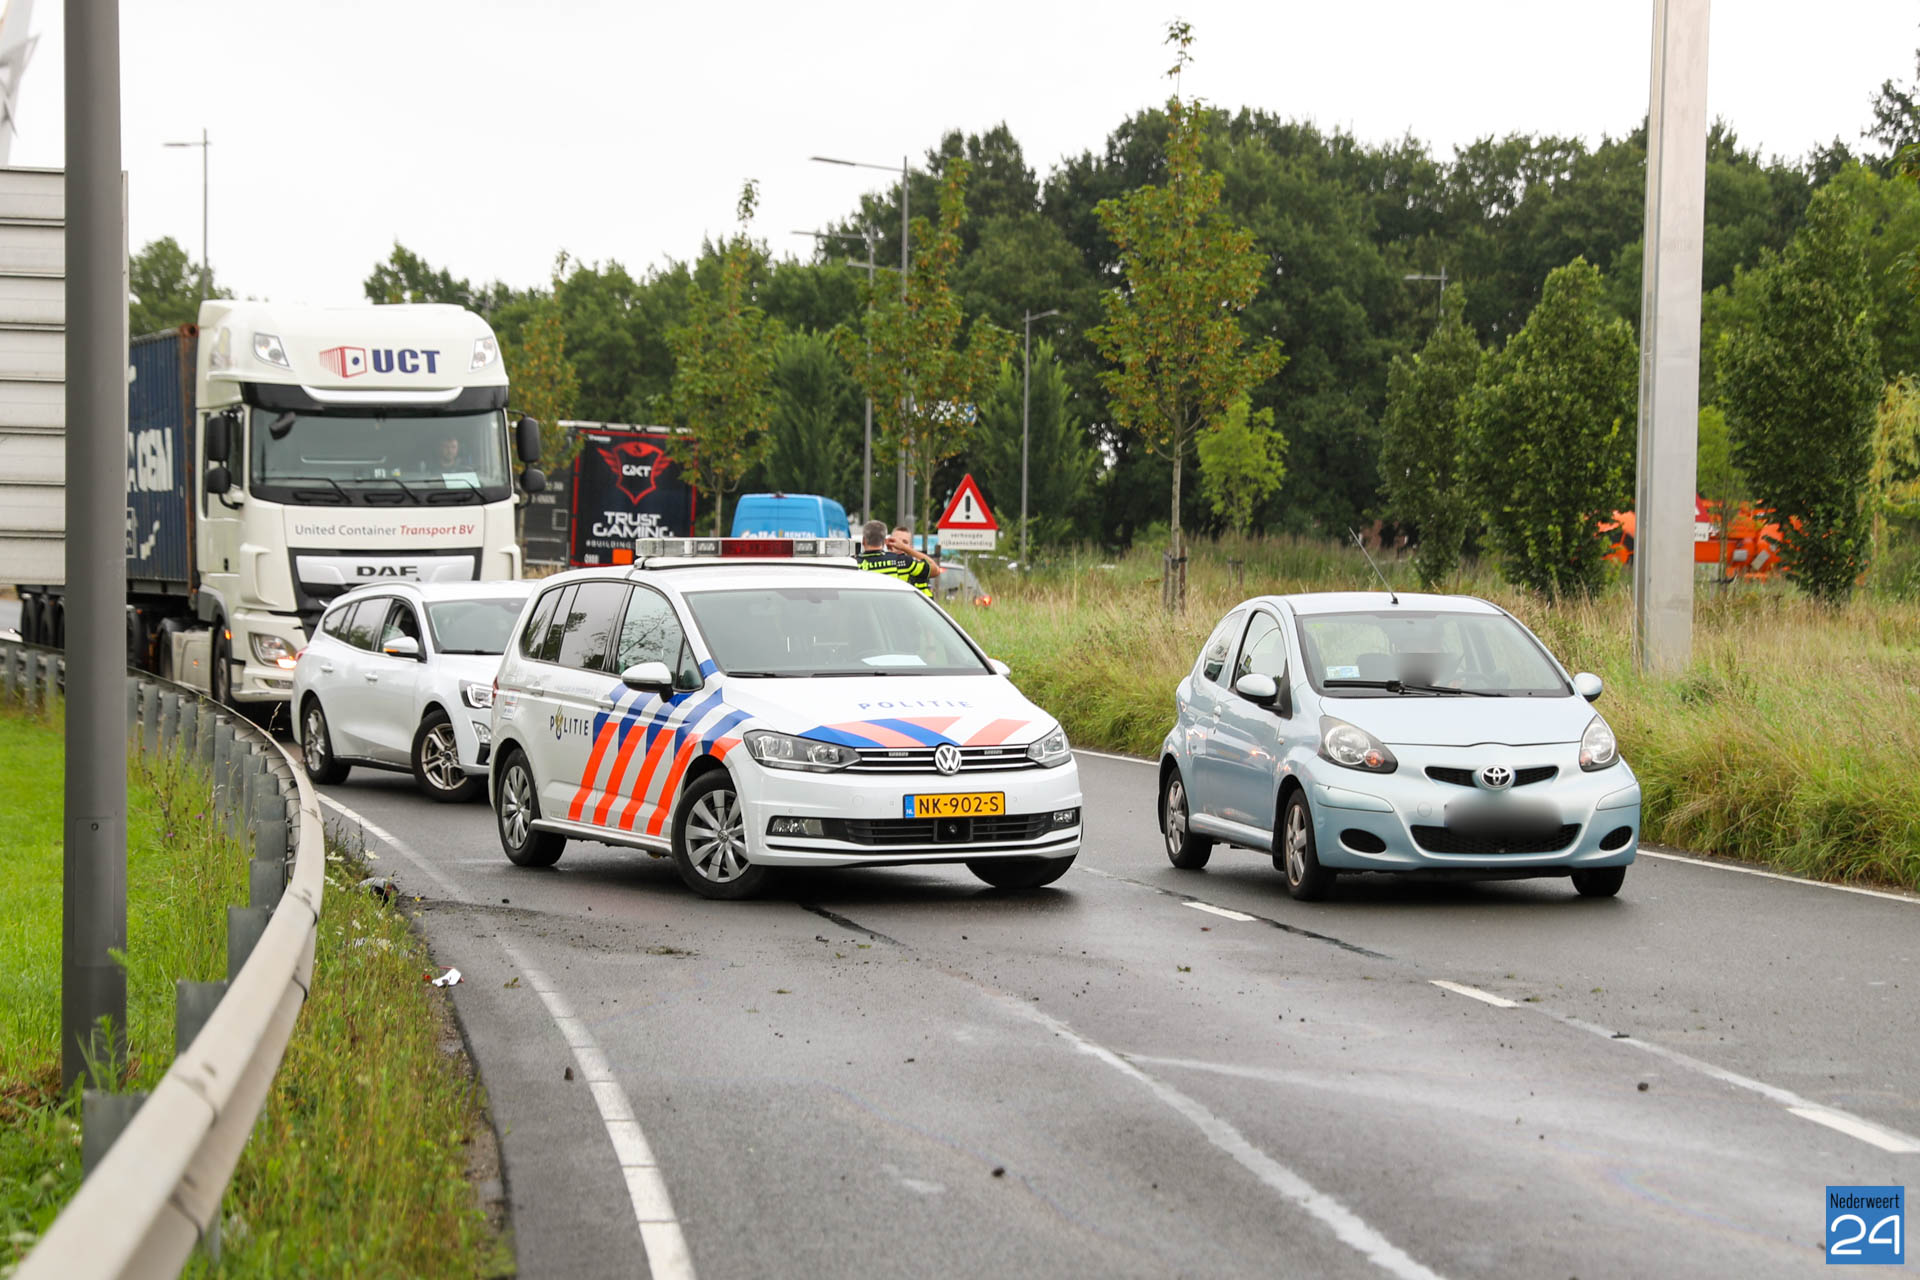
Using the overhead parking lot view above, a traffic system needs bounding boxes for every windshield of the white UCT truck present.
[250,409,513,507]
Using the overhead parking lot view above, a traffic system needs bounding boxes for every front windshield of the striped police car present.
[685,587,989,677]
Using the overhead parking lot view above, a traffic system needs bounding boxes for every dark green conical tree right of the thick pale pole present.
[1718,184,1880,603]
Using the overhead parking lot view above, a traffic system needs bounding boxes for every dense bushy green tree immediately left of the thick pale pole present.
[1463,257,1640,597]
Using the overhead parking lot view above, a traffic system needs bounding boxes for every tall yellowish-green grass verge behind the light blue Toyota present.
[954,539,1920,889]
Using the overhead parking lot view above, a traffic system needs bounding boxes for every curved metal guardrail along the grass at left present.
[0,641,326,1280]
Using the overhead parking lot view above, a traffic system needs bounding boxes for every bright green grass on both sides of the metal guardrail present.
[0,710,513,1276]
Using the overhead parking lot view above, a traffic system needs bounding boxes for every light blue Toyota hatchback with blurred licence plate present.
[1160,591,1640,900]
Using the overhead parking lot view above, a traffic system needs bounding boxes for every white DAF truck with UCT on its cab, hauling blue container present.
[19,301,545,714]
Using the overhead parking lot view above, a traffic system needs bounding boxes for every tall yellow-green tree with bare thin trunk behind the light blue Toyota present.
[1087,21,1283,610]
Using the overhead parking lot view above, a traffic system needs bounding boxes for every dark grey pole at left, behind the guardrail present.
[60,0,127,1088]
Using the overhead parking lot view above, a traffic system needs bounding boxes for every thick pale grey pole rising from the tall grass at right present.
[1634,0,1707,672]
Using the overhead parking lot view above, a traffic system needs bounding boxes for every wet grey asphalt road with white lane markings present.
[319,756,1920,1278]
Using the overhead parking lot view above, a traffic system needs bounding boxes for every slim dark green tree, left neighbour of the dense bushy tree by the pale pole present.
[1380,284,1486,591]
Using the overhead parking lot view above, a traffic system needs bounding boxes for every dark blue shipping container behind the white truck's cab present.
[127,324,198,591]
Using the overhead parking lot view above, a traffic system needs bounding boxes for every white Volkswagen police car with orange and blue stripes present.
[490,537,1081,898]
